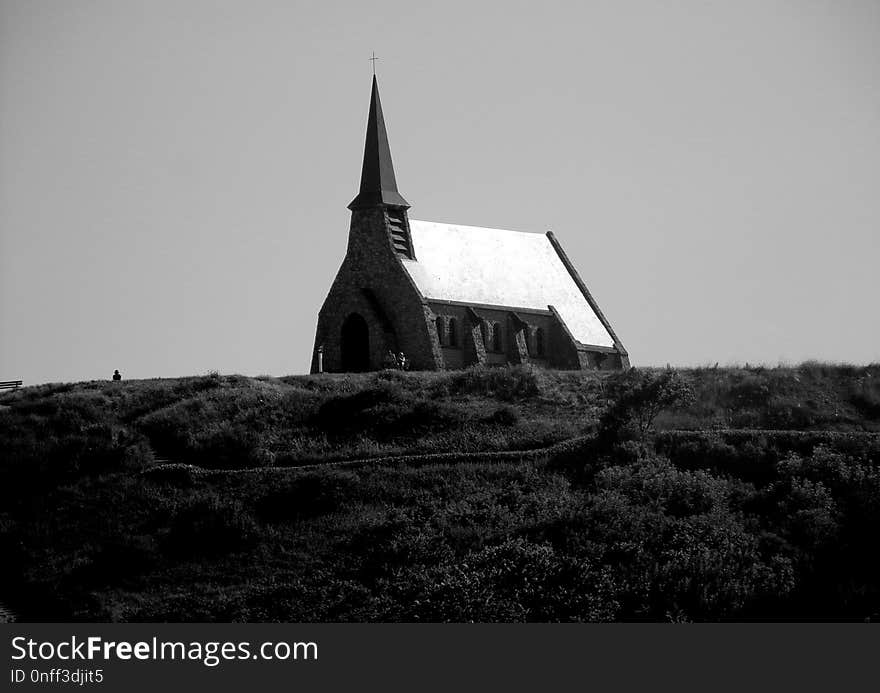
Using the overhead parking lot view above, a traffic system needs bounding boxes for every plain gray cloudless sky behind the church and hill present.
[0,0,880,383]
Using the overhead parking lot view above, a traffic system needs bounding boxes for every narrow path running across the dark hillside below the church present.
[142,428,880,476]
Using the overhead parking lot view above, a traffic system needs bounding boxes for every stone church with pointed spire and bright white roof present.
[311,75,629,373]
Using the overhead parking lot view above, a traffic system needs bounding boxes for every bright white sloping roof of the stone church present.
[403,219,614,347]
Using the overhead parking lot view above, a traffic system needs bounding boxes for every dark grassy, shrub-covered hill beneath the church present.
[0,363,880,621]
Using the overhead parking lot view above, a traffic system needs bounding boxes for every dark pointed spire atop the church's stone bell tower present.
[348,75,409,209]
